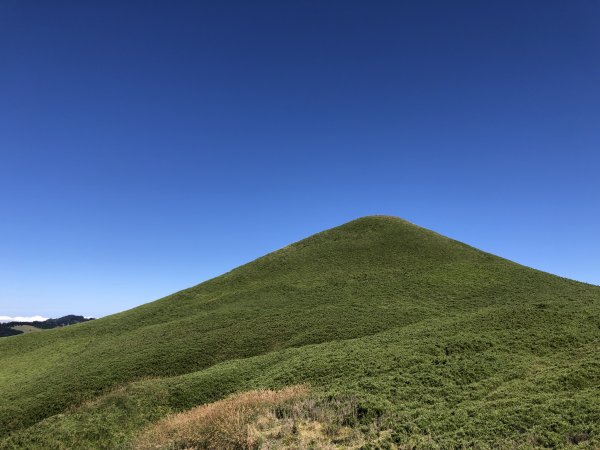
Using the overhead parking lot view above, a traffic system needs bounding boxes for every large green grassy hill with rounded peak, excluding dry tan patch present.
[0,217,600,449]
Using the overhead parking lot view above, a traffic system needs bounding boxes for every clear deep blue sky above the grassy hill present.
[0,0,600,317]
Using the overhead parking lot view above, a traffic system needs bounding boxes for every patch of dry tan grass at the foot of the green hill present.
[134,386,389,450]
